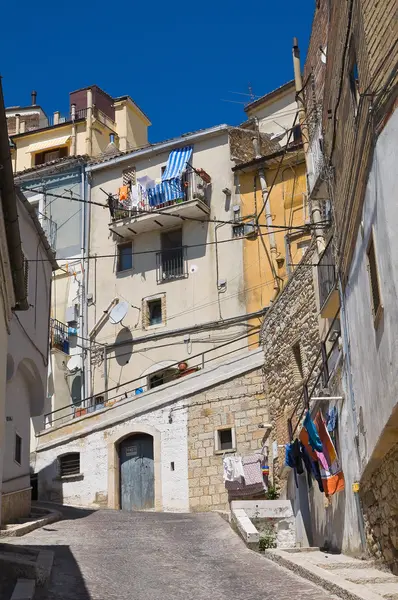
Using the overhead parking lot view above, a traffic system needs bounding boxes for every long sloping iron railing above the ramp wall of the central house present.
[44,326,265,429]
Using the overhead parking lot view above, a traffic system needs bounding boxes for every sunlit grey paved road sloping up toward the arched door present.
[13,509,333,600]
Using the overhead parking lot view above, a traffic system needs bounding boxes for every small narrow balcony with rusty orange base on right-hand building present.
[317,240,340,319]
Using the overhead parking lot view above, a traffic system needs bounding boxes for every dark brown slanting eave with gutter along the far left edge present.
[0,80,29,310]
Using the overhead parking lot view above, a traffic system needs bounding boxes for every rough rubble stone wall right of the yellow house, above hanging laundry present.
[261,246,320,483]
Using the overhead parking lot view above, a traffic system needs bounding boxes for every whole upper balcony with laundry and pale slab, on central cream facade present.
[108,171,210,239]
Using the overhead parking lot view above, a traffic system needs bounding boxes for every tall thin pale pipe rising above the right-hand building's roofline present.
[293,38,325,255]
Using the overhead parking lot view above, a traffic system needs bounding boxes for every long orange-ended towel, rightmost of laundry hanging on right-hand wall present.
[315,412,345,496]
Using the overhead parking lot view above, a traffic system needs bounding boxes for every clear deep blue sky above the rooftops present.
[0,0,315,142]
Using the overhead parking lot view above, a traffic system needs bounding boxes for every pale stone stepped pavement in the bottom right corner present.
[266,548,398,600]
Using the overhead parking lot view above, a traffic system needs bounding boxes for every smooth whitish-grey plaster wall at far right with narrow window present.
[345,110,398,469]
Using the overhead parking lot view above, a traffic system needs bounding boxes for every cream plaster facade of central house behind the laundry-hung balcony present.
[88,132,247,404]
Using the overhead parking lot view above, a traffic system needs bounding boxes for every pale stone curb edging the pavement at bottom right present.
[264,550,385,600]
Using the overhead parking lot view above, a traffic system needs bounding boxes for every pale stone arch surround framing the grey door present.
[108,423,163,511]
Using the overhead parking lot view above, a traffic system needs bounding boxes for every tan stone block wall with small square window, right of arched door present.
[188,369,268,511]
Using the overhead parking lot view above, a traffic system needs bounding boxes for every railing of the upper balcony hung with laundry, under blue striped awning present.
[108,171,208,221]
